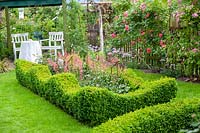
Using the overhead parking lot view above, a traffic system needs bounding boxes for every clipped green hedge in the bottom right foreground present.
[93,99,200,133]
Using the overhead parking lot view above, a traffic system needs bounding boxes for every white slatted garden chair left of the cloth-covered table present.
[11,33,29,60]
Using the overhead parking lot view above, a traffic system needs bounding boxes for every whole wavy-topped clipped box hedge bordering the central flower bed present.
[16,60,177,126]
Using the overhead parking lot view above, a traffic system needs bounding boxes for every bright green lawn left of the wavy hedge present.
[0,71,91,133]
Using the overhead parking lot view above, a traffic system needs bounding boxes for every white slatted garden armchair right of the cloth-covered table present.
[40,32,64,57]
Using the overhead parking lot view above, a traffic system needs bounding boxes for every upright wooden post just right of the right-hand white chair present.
[62,0,70,52]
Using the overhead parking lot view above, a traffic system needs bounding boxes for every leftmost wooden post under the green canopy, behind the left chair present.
[5,7,12,50]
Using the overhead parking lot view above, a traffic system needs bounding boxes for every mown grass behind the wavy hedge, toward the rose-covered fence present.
[134,70,200,99]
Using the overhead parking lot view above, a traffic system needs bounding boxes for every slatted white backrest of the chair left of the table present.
[11,33,28,43]
